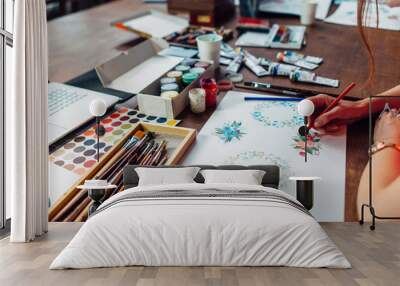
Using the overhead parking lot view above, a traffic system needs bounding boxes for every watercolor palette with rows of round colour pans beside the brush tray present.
[49,107,180,176]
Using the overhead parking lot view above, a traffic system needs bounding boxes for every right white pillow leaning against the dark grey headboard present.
[200,170,265,185]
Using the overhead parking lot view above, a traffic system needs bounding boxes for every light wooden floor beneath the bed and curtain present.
[0,222,400,286]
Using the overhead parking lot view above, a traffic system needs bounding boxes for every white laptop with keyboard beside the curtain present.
[47,82,120,144]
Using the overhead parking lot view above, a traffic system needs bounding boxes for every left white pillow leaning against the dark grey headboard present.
[135,167,200,186]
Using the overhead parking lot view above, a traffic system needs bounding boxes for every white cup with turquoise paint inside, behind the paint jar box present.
[196,34,222,68]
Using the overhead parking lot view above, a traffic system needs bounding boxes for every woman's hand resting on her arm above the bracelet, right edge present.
[374,109,400,144]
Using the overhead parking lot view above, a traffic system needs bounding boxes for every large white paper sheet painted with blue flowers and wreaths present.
[182,92,346,221]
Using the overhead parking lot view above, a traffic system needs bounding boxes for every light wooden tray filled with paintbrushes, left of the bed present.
[49,123,196,222]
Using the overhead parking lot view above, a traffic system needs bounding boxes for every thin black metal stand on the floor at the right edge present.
[359,95,400,230]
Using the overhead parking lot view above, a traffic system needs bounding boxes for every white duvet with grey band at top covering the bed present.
[50,183,351,269]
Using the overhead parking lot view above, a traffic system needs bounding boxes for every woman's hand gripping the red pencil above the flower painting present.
[308,94,368,133]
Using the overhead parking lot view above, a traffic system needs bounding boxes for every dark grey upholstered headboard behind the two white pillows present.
[123,165,279,190]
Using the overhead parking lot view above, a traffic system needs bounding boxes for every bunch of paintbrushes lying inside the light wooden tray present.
[49,130,167,222]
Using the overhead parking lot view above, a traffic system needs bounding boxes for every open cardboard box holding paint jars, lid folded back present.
[96,39,214,118]
